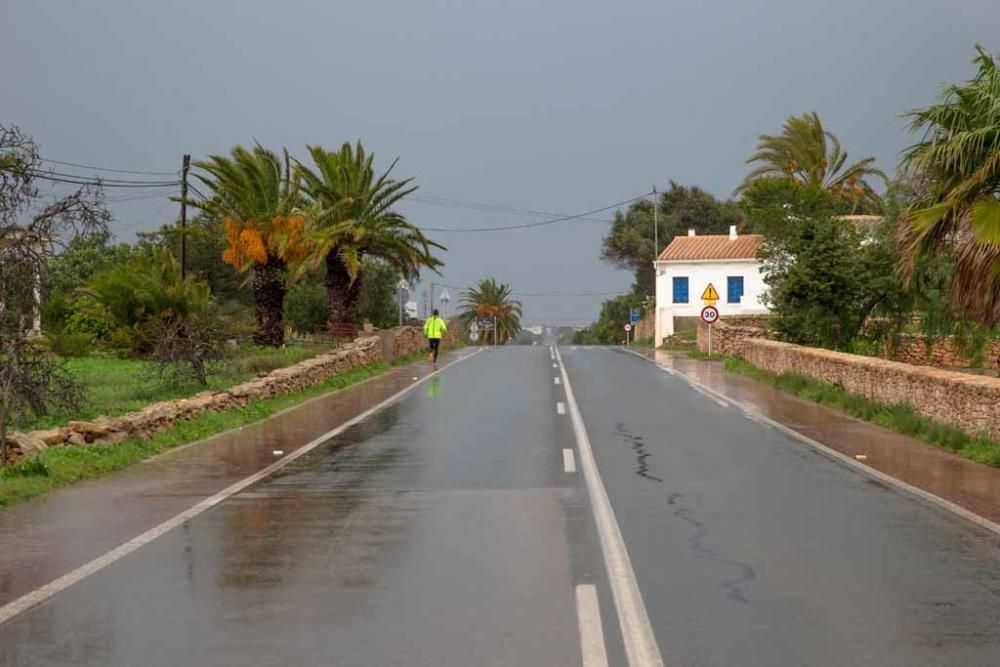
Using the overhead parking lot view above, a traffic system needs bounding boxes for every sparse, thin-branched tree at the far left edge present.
[0,124,110,466]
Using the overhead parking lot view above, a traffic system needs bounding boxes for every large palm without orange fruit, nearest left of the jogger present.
[299,141,445,333]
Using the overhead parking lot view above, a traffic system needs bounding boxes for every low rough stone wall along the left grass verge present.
[2,334,386,460]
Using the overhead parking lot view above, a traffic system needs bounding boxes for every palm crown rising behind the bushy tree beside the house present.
[736,111,888,213]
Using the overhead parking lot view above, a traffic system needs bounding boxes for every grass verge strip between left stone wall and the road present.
[0,362,389,508]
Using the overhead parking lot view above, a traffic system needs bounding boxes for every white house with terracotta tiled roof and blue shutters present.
[654,226,769,347]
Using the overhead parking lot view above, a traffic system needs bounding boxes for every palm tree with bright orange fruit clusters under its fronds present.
[182,145,305,347]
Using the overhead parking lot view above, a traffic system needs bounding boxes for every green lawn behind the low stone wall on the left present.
[17,345,332,431]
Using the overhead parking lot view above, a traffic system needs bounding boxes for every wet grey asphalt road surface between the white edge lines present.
[0,347,1000,666]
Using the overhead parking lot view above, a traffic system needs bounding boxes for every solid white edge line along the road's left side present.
[0,351,479,625]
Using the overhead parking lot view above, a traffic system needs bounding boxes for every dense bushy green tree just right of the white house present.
[743,178,902,349]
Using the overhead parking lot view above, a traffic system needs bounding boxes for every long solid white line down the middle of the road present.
[556,351,663,667]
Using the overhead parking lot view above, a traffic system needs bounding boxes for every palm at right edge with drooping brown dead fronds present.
[897,44,1000,327]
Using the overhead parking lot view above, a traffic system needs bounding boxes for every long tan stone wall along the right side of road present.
[739,338,1000,438]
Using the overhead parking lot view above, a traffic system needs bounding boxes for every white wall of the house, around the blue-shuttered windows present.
[655,259,770,346]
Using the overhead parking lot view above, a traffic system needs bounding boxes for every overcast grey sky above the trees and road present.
[0,0,1000,323]
